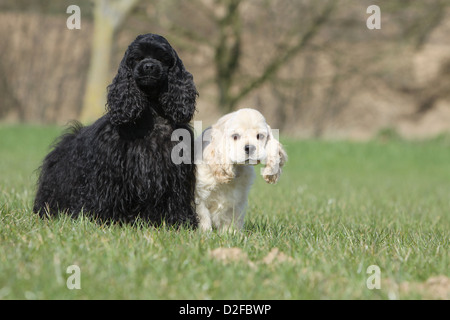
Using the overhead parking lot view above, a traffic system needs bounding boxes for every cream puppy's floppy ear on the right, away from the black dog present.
[261,125,287,184]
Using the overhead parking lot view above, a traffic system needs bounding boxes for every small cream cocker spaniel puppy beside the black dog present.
[195,109,287,231]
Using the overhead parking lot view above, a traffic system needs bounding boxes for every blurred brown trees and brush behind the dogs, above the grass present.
[0,0,450,139]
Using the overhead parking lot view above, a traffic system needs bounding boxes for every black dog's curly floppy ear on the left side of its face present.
[106,49,146,125]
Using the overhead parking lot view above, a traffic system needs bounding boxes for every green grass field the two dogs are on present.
[0,126,450,299]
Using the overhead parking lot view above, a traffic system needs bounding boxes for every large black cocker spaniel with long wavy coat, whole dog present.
[33,34,198,227]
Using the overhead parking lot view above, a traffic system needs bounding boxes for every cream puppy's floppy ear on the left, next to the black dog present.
[203,120,235,183]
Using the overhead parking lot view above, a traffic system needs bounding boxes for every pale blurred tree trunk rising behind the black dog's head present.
[80,0,139,123]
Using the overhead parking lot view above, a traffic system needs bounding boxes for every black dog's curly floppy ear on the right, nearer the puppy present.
[159,54,198,123]
